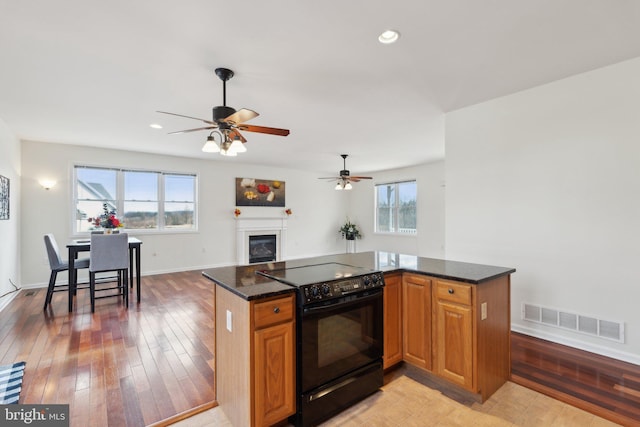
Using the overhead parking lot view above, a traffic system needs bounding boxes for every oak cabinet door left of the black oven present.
[254,322,296,426]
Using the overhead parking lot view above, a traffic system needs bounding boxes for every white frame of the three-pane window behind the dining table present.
[70,163,200,236]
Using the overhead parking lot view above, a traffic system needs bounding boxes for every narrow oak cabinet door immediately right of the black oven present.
[383,274,402,369]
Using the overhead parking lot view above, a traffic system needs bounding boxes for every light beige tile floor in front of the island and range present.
[175,375,617,427]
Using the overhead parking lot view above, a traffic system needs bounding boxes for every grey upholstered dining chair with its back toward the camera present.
[89,233,129,313]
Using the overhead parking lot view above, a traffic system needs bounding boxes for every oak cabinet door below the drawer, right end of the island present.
[434,300,473,390]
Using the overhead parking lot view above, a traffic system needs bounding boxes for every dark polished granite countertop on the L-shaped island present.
[202,252,516,300]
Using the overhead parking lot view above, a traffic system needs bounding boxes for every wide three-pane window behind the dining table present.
[73,166,196,233]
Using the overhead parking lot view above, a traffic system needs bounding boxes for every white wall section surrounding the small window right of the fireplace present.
[344,161,445,258]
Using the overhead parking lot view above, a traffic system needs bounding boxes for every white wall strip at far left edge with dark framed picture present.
[0,120,21,309]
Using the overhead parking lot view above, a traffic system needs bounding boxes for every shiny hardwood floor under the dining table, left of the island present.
[0,271,215,427]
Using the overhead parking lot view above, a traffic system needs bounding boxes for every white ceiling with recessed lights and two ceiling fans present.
[0,0,640,174]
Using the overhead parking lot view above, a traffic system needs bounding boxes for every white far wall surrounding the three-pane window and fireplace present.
[21,141,346,286]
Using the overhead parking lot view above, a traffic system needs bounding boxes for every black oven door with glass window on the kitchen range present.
[298,288,383,393]
